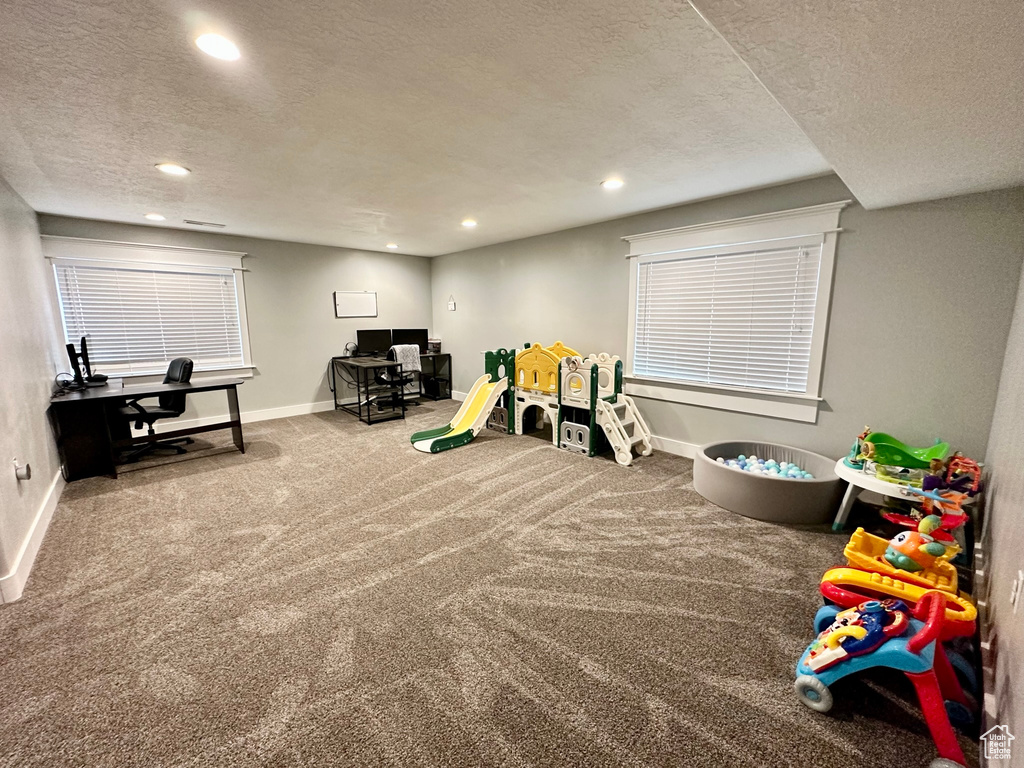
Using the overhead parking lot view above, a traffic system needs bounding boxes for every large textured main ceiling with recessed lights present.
[0,0,829,255]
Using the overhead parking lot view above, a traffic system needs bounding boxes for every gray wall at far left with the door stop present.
[0,178,58,579]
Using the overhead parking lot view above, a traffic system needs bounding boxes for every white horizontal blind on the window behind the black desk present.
[53,261,246,375]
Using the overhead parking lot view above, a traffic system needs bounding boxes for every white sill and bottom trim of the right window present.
[624,376,820,424]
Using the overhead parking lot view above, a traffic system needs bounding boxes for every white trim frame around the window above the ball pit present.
[623,200,853,423]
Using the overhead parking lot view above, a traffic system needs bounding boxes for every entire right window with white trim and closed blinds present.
[627,203,845,421]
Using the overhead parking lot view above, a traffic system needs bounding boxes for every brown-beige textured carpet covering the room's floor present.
[0,402,974,768]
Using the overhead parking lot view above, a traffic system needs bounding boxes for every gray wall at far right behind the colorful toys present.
[983,262,1024,766]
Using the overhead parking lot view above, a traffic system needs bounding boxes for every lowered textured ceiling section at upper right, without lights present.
[693,0,1024,208]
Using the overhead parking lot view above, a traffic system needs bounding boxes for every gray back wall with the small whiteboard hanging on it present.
[39,215,430,418]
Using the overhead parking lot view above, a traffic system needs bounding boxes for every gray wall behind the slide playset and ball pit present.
[432,176,1024,458]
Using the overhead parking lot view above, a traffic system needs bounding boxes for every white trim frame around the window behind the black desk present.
[40,234,256,382]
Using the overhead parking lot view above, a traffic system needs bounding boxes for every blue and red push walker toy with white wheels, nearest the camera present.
[794,592,966,768]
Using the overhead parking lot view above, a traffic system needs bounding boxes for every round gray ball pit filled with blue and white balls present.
[693,440,844,525]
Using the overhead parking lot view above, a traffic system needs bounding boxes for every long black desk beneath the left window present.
[48,379,246,481]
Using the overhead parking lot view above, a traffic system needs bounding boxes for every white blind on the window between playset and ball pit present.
[633,242,821,393]
